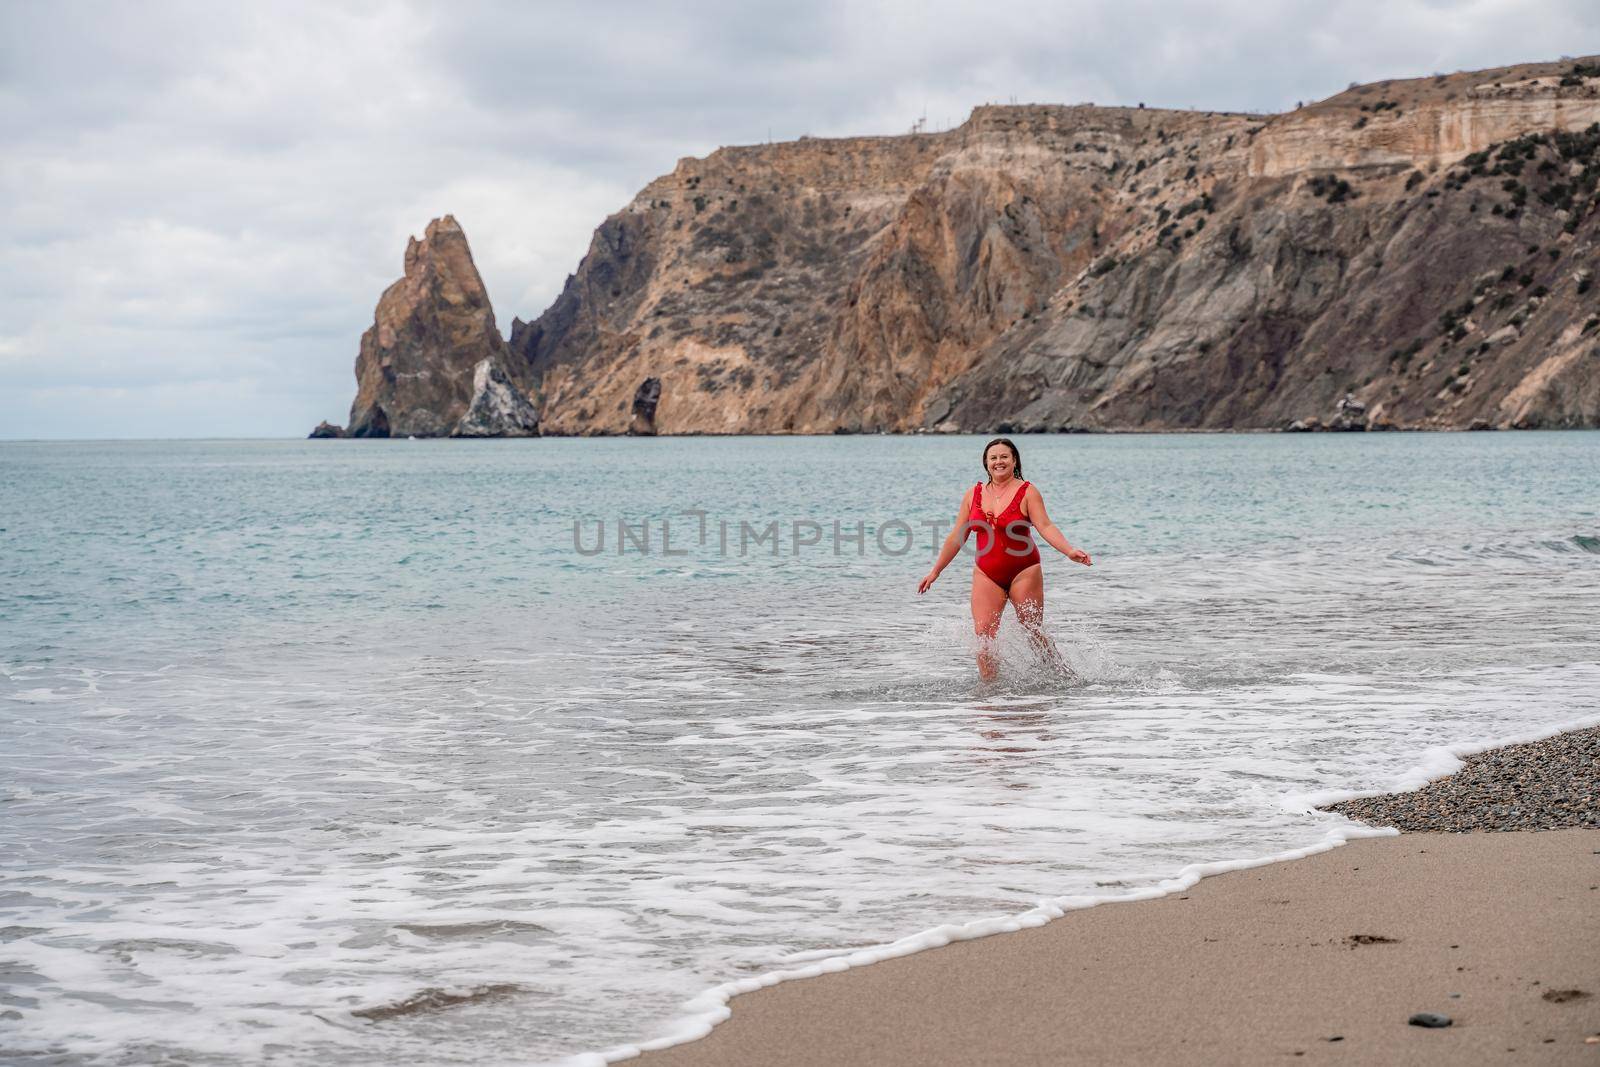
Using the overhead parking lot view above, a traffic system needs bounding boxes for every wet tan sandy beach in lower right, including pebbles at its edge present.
[643,731,1600,1067]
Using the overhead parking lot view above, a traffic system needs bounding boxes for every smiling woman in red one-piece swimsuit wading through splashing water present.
[917,437,1091,681]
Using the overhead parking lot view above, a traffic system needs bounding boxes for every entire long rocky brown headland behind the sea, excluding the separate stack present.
[510,61,1600,434]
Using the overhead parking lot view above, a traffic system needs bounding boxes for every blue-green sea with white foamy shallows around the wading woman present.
[0,432,1600,1065]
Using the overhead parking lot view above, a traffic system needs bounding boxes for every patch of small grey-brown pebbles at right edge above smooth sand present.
[1323,726,1600,833]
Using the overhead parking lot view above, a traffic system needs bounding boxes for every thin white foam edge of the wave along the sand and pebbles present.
[572,715,1600,1067]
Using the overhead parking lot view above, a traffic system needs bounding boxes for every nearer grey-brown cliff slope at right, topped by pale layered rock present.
[934,66,1600,429]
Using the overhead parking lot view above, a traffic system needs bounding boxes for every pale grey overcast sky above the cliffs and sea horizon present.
[0,0,1600,438]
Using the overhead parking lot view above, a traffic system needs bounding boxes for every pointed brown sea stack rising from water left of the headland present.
[346,214,531,437]
